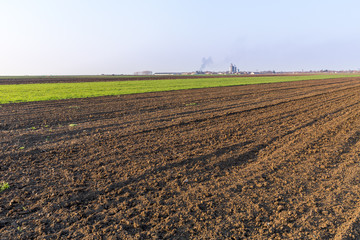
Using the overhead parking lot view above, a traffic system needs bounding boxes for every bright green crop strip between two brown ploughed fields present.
[0,75,359,104]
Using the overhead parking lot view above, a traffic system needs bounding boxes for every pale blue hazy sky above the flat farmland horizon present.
[0,0,360,75]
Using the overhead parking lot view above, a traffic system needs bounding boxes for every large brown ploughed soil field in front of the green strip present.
[0,78,360,239]
